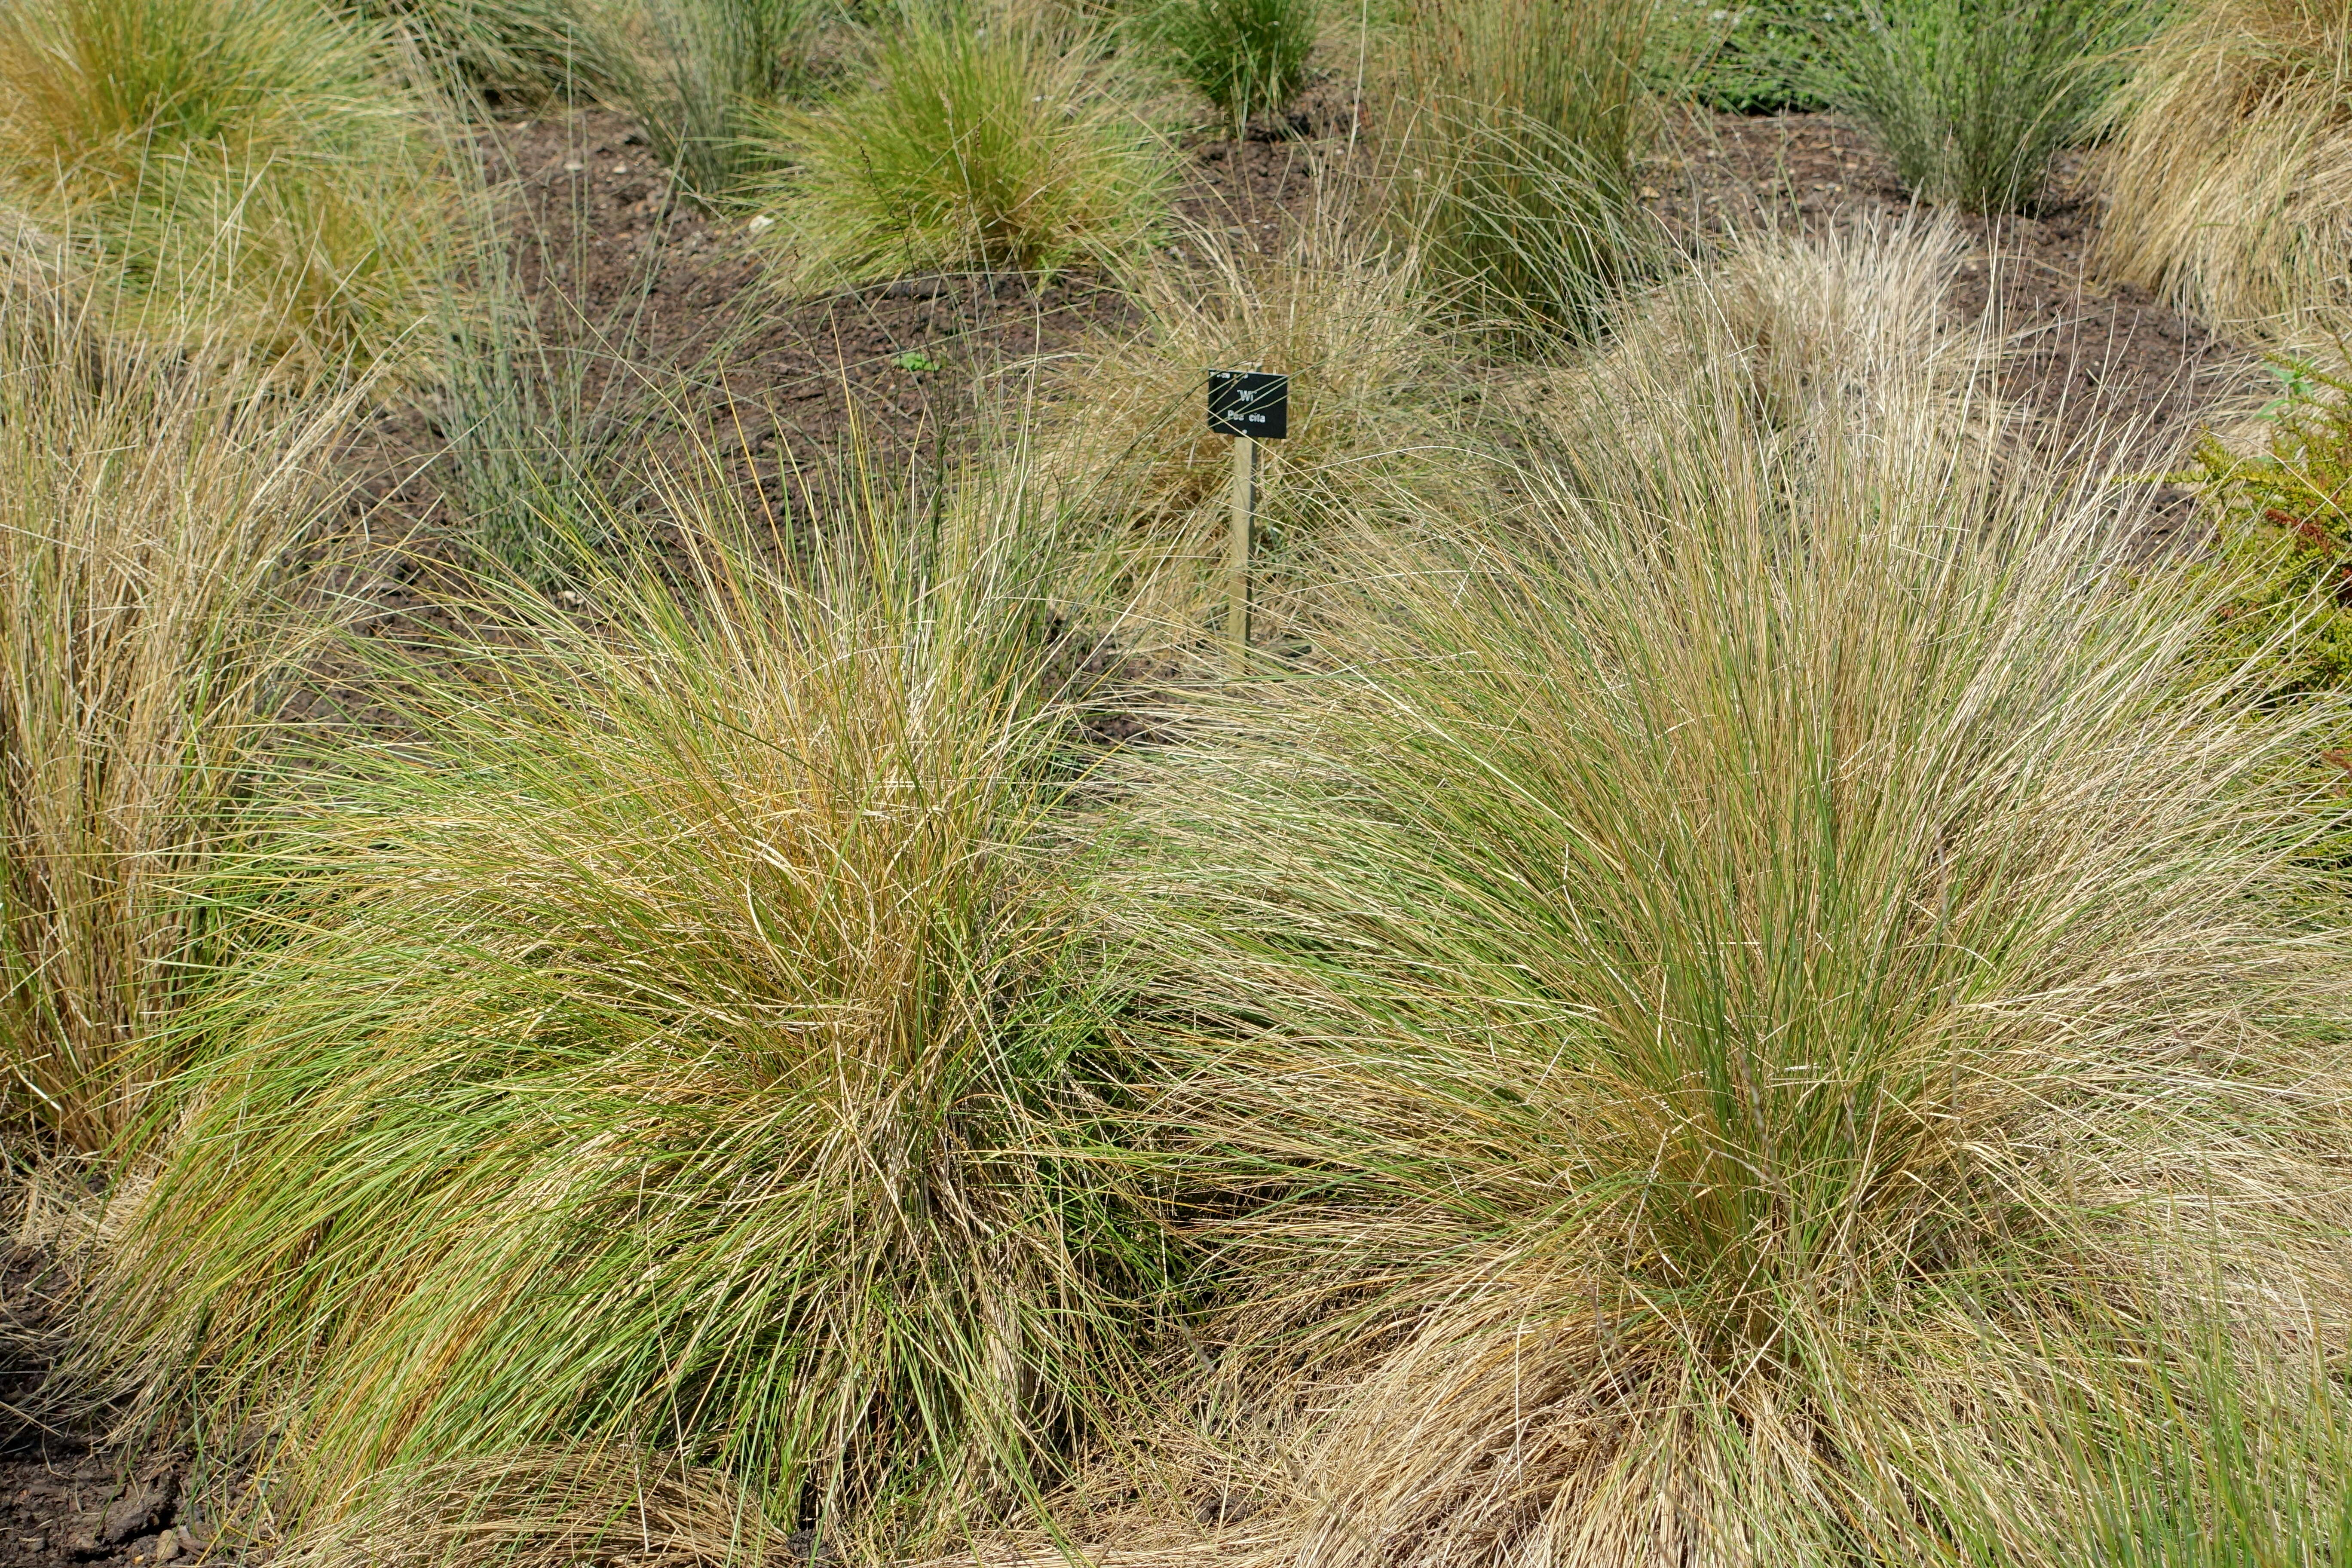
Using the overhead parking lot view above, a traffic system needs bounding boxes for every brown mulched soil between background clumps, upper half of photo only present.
[350,100,2256,594]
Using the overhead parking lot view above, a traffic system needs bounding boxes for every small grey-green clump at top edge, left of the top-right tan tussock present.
[1813,0,2154,211]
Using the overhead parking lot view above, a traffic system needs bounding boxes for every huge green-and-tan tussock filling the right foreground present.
[1096,270,2352,1566]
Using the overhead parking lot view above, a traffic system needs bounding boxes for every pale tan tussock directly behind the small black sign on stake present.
[1030,211,1479,649]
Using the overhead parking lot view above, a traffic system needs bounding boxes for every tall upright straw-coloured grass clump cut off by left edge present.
[0,280,348,1149]
